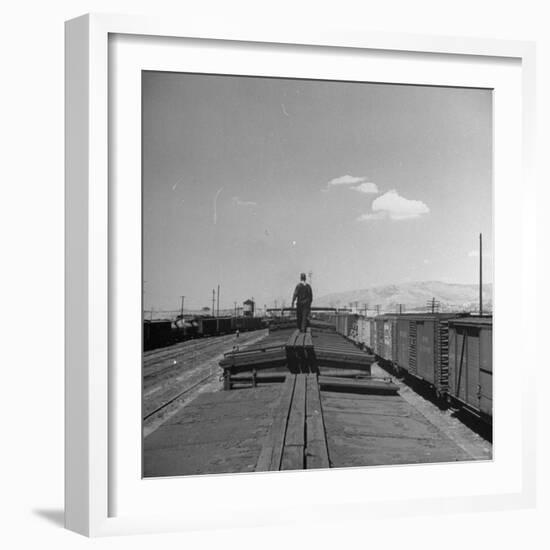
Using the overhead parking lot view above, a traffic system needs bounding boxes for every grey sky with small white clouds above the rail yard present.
[142,71,493,310]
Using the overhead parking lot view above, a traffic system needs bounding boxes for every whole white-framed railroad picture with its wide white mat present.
[66,15,536,536]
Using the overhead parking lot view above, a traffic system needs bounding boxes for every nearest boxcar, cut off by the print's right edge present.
[448,317,493,422]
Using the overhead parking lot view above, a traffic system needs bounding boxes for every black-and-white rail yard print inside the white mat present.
[143,71,498,478]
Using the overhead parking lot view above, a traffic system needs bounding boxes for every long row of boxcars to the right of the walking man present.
[330,313,493,423]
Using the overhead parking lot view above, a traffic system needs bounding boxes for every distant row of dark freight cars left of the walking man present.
[143,316,265,351]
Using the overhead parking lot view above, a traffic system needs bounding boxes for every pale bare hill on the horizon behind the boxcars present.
[313,281,493,312]
